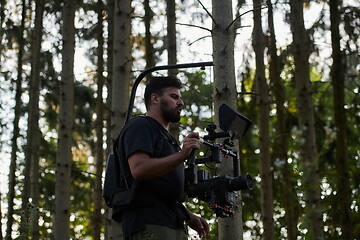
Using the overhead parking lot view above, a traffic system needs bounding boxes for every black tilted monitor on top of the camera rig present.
[219,103,252,140]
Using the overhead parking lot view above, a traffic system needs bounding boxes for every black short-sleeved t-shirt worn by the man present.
[118,117,185,239]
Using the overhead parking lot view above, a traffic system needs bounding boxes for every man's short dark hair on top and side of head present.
[144,76,182,109]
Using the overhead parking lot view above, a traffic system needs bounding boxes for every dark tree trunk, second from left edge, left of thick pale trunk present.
[26,0,44,240]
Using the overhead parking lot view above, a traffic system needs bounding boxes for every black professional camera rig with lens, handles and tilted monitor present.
[185,104,253,218]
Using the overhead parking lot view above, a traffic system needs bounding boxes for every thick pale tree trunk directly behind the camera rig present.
[212,0,243,240]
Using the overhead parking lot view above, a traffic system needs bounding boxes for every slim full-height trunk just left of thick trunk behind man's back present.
[92,0,104,240]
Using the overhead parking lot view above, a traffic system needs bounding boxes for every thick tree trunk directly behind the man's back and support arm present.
[109,0,132,239]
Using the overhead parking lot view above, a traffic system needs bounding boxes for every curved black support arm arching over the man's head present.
[125,62,214,123]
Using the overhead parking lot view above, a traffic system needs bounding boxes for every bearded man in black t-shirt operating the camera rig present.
[117,76,209,240]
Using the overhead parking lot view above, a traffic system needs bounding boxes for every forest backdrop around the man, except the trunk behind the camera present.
[0,0,360,239]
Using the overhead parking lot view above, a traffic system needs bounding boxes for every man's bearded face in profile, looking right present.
[160,87,184,123]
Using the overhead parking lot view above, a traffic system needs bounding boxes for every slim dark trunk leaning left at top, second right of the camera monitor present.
[267,0,298,240]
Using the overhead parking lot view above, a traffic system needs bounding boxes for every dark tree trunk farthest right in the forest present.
[329,0,353,239]
